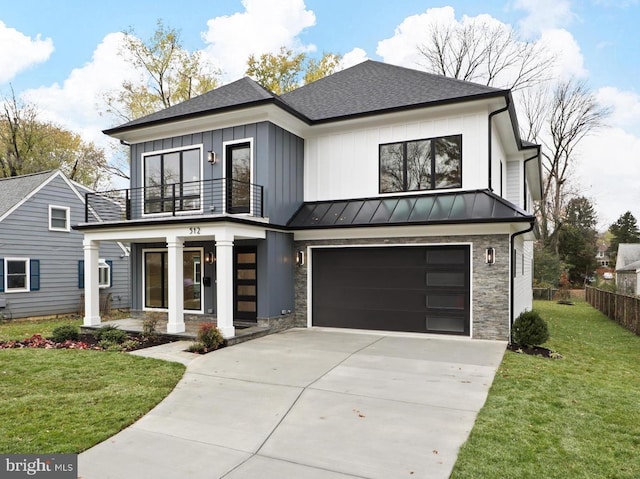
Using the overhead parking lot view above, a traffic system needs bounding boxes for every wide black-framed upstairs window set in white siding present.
[380,135,462,193]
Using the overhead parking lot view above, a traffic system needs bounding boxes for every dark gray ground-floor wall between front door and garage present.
[258,231,296,318]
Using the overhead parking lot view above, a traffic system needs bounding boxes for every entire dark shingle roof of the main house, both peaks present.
[104,60,508,135]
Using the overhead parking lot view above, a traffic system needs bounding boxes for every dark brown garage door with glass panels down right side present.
[311,246,469,335]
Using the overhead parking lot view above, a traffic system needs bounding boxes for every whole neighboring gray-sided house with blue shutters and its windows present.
[0,170,130,318]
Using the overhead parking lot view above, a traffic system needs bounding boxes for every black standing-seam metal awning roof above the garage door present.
[287,190,534,229]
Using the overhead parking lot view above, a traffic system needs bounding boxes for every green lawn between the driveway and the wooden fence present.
[451,301,640,479]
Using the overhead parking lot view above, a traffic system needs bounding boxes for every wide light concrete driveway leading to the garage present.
[79,329,506,479]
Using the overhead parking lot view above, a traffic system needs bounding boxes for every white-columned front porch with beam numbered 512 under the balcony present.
[79,217,266,339]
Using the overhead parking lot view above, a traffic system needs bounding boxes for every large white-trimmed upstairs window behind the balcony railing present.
[143,148,201,214]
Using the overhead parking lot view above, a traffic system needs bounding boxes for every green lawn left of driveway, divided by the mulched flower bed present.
[0,320,185,454]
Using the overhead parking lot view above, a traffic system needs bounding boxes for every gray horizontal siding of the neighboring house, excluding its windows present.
[0,176,129,318]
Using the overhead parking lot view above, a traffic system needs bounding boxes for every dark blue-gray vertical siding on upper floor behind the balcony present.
[131,122,304,225]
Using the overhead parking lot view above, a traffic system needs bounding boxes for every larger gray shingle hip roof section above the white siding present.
[281,60,507,122]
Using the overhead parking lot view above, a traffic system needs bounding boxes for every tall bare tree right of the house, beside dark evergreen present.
[523,79,610,253]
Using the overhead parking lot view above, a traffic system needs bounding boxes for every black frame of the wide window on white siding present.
[378,134,463,194]
